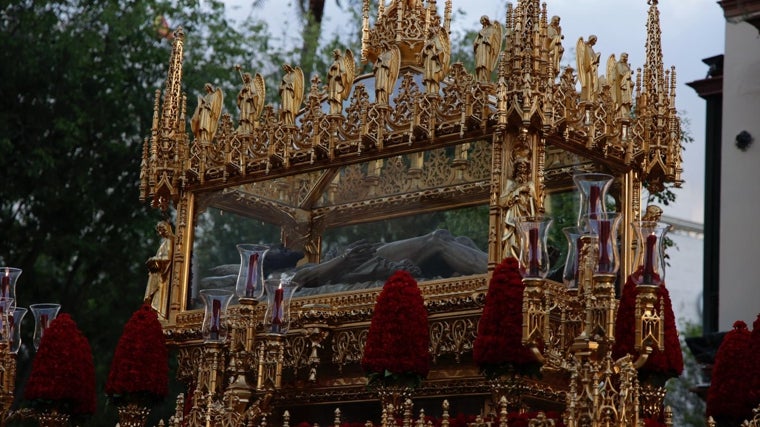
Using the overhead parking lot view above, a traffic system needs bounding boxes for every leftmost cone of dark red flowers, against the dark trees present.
[24,313,95,416]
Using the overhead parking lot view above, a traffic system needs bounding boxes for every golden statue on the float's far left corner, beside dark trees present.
[144,221,174,316]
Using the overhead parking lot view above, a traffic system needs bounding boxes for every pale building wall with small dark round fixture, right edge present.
[718,22,760,331]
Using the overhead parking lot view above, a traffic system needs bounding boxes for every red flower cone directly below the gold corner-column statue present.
[472,257,541,378]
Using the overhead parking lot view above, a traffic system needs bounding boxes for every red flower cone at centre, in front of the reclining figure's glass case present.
[362,270,430,386]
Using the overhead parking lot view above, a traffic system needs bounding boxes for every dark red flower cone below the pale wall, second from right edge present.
[707,320,756,425]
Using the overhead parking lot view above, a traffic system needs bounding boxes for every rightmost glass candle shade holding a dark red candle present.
[631,221,670,285]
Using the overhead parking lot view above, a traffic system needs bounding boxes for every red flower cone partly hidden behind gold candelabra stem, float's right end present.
[612,275,683,383]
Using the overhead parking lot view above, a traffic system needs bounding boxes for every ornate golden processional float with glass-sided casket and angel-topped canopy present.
[135,0,681,426]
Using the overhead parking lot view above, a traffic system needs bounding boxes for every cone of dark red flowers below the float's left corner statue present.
[106,304,169,400]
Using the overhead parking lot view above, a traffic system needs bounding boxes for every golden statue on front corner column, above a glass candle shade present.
[499,157,536,258]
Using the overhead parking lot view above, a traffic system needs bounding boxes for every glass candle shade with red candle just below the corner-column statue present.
[517,216,552,279]
